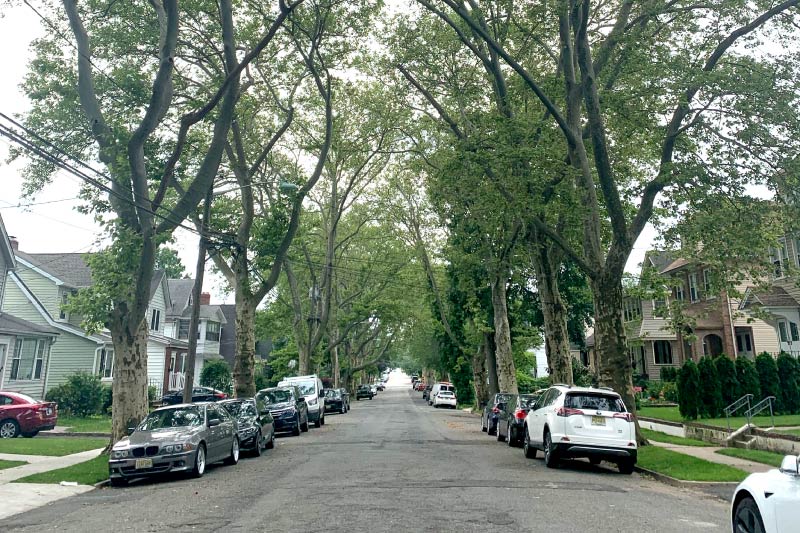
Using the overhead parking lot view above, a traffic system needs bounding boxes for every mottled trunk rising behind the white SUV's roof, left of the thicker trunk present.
[533,245,572,385]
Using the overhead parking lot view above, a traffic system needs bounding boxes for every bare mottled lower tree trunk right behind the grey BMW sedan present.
[110,318,149,445]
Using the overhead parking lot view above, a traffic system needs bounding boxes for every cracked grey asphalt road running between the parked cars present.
[0,374,729,533]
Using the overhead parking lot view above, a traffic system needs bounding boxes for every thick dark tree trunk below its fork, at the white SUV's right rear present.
[591,276,647,445]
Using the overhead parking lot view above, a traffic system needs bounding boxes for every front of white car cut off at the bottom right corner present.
[731,455,800,533]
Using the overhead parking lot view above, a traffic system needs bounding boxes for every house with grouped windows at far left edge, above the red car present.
[0,217,60,398]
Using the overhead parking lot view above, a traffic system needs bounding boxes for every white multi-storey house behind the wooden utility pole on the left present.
[164,278,225,389]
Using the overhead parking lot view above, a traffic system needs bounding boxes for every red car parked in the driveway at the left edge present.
[0,391,58,439]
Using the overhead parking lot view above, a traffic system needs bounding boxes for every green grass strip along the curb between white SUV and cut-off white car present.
[637,446,748,482]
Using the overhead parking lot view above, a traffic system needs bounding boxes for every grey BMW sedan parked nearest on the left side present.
[108,403,239,486]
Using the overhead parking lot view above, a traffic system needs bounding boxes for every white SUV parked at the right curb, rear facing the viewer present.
[523,385,636,474]
